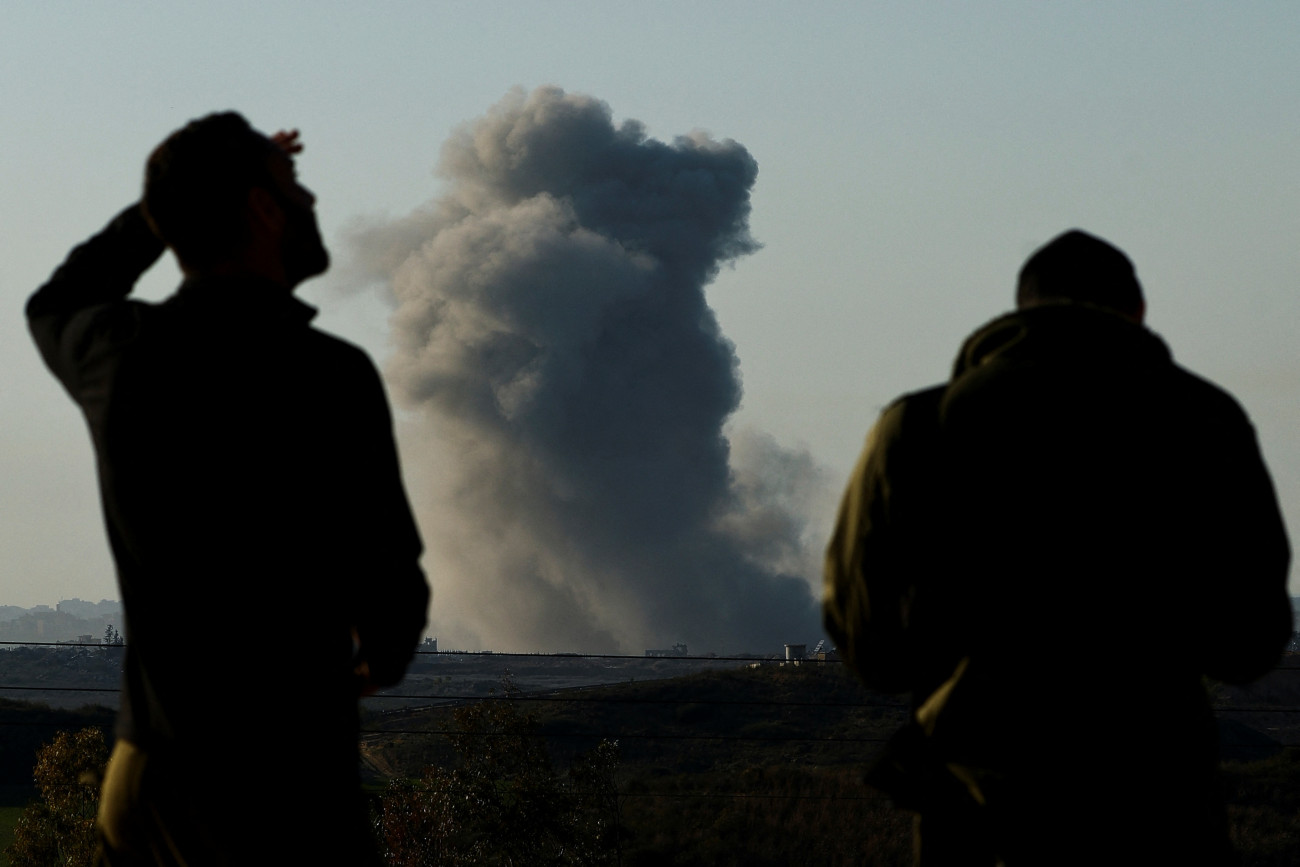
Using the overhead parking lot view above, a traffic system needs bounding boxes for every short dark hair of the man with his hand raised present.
[142,112,274,269]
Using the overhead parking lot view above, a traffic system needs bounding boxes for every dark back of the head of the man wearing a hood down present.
[1015,229,1145,315]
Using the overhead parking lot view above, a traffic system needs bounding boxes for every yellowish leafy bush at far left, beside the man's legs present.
[5,728,108,867]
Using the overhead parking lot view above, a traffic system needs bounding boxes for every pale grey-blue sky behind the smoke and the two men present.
[0,0,1300,631]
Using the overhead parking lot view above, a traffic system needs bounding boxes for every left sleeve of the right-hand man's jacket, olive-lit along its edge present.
[823,389,943,693]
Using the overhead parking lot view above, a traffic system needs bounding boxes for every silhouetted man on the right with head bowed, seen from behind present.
[824,231,1291,867]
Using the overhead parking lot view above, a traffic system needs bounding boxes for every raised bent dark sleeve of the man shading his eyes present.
[26,205,164,398]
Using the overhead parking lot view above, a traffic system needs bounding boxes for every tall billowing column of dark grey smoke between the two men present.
[355,87,820,653]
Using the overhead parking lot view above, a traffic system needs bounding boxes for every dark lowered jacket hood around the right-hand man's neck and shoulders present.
[953,303,1173,380]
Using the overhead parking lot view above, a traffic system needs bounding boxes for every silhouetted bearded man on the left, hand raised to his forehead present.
[27,113,428,866]
